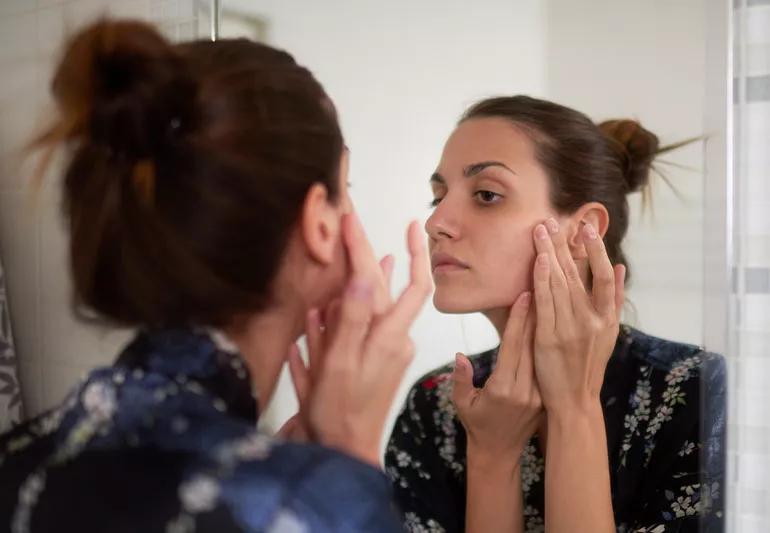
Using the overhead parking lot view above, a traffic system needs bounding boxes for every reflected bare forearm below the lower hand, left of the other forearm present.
[465,446,523,533]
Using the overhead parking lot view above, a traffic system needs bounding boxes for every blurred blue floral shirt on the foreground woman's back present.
[0,330,403,533]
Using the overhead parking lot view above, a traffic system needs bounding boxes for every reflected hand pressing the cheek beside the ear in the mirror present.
[534,219,625,413]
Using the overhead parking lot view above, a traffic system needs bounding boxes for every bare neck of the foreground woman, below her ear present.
[225,304,304,410]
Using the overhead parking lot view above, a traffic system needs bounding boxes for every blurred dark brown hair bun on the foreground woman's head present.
[52,19,194,158]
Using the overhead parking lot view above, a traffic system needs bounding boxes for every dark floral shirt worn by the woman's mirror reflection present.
[385,326,725,533]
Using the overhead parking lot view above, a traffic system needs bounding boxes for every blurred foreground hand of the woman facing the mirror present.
[292,214,431,466]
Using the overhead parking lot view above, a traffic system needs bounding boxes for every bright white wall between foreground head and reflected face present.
[223,0,549,427]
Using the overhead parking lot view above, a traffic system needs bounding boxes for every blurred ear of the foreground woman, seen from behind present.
[300,183,341,266]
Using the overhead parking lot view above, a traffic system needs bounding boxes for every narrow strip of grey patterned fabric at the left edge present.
[0,265,22,433]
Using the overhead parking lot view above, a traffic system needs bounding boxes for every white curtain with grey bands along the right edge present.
[728,0,770,533]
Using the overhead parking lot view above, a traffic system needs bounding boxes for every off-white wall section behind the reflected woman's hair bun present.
[547,0,708,345]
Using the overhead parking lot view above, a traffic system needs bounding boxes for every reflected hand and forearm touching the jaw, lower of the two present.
[452,292,543,533]
